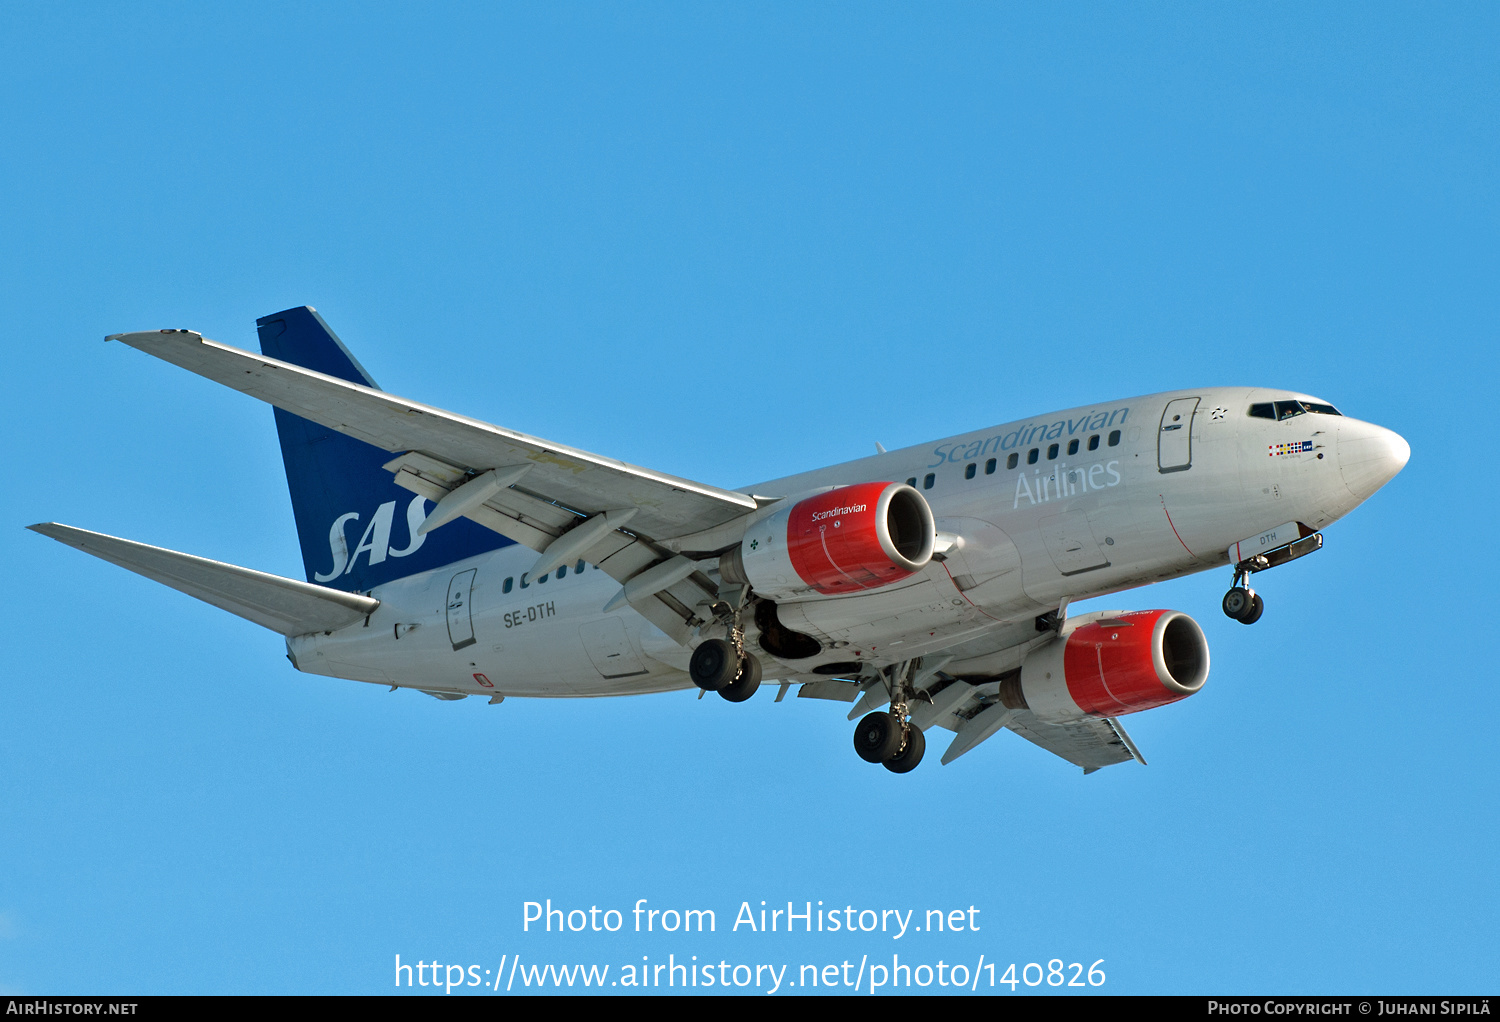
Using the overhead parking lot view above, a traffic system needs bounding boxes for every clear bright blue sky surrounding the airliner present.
[0,3,1500,993]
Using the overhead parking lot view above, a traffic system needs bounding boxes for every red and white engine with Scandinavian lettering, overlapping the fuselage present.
[719,483,938,597]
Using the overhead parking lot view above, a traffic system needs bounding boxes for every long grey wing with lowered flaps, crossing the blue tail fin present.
[108,330,759,642]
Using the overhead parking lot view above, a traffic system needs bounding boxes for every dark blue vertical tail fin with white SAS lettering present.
[255,306,512,593]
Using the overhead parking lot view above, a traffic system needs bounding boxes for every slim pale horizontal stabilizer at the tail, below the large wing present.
[27,522,380,635]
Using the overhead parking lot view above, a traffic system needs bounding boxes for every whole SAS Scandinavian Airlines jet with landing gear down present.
[30,306,1410,773]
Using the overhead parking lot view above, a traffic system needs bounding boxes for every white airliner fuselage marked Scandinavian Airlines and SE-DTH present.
[288,387,1409,696]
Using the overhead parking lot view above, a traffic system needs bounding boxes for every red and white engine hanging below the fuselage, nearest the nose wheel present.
[1001,611,1209,723]
